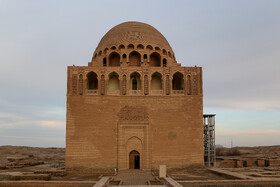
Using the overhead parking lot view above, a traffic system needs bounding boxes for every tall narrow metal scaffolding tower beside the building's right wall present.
[203,114,216,167]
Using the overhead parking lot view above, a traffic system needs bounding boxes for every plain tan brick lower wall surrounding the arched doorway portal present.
[66,96,203,170]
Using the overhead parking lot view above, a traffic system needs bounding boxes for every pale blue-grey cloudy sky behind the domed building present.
[0,0,280,147]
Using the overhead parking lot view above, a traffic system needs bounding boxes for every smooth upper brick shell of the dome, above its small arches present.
[94,22,174,55]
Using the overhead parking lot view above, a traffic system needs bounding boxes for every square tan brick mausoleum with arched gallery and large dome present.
[66,22,204,171]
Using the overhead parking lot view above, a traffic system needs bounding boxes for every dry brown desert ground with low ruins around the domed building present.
[0,146,280,186]
